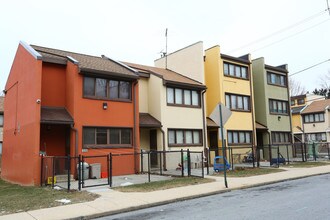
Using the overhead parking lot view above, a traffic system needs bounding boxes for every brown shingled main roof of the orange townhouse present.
[31,45,138,79]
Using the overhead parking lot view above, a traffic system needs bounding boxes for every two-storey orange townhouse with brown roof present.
[1,42,140,185]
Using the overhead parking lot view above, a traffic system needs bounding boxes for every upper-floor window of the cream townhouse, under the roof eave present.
[167,87,200,107]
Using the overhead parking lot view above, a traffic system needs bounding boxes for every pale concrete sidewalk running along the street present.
[0,165,330,220]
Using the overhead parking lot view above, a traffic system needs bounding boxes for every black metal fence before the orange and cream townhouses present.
[40,150,205,190]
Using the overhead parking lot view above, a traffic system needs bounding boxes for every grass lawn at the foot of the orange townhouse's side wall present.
[0,179,98,216]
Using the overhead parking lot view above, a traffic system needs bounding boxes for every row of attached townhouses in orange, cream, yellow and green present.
[1,42,293,185]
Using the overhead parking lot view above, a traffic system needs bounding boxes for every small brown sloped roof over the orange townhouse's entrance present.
[40,107,73,124]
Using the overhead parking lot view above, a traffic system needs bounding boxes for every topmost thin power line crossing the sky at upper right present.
[229,7,330,53]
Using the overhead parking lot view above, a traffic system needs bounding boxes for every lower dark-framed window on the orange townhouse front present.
[83,127,132,148]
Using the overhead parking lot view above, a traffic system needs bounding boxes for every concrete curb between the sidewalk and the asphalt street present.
[70,172,330,220]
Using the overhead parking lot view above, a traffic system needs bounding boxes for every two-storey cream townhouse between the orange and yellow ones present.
[125,63,206,168]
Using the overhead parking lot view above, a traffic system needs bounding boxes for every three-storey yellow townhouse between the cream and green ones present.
[204,46,256,158]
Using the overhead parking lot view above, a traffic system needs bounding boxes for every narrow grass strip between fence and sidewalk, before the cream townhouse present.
[113,177,215,192]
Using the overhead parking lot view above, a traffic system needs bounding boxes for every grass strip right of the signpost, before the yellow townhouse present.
[213,167,285,177]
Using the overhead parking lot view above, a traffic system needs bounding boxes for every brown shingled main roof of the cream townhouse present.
[123,62,206,89]
